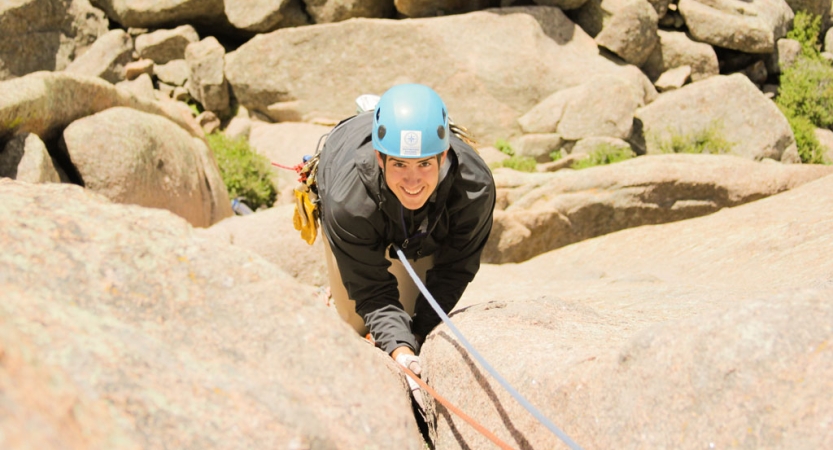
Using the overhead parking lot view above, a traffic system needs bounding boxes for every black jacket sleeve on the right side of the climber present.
[412,158,496,337]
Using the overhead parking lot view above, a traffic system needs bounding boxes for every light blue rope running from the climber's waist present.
[393,245,582,450]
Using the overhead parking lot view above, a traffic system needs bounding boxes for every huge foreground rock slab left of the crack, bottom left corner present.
[0,180,424,450]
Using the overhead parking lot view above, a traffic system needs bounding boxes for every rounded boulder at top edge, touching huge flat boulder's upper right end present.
[570,0,659,66]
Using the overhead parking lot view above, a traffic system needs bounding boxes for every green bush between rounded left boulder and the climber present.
[207,133,278,210]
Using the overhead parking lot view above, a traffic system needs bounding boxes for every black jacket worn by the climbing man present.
[317,113,495,353]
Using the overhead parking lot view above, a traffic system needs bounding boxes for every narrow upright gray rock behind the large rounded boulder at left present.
[185,36,230,117]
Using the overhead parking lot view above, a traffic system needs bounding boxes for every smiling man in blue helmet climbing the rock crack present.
[317,84,495,398]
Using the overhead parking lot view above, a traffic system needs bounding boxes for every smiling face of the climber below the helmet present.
[376,150,448,210]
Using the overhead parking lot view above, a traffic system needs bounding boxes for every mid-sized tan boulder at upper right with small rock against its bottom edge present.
[642,30,720,81]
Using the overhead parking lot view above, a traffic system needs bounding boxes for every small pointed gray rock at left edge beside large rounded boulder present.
[0,133,61,183]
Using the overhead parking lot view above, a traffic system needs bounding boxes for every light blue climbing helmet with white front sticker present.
[373,84,448,158]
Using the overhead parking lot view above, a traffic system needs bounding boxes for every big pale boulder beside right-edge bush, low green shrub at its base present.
[635,74,797,161]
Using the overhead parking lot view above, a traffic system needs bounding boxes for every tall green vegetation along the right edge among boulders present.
[775,11,833,164]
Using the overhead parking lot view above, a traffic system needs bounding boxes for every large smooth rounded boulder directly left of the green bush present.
[61,107,232,227]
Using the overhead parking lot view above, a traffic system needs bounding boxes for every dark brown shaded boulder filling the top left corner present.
[0,0,108,81]
